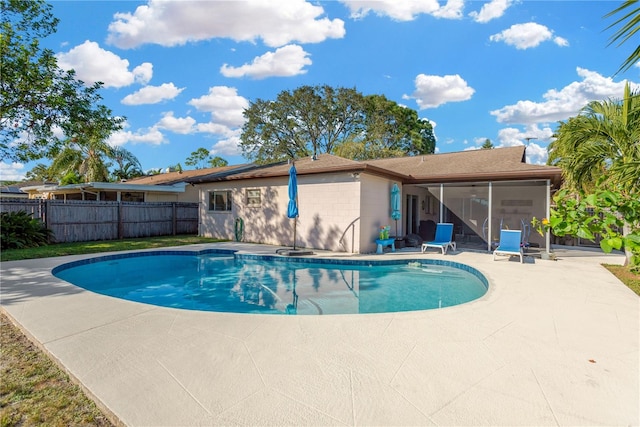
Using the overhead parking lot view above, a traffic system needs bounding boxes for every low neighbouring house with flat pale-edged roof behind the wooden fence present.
[23,165,244,203]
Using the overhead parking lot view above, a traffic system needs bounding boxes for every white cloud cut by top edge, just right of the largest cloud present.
[341,0,464,21]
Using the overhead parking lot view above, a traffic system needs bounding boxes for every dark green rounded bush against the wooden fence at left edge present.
[0,211,53,250]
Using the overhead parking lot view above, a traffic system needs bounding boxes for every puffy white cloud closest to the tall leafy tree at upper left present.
[56,40,153,87]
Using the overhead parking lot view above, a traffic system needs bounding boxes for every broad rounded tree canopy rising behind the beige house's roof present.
[240,85,435,163]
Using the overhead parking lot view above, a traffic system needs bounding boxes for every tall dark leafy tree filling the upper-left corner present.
[0,0,124,161]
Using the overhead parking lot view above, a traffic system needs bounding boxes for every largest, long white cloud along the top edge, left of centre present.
[107,0,345,48]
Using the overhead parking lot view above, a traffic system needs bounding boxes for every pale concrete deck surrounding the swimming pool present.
[0,243,640,426]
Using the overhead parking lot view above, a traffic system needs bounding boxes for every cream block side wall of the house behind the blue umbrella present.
[197,173,361,252]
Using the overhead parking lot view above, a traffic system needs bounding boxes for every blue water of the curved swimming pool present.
[53,251,488,315]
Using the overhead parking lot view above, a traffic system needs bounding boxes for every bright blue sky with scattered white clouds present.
[0,0,640,180]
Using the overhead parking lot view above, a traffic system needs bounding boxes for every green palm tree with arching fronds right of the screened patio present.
[549,83,640,263]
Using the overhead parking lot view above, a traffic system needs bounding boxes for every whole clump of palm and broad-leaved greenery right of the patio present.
[534,84,640,268]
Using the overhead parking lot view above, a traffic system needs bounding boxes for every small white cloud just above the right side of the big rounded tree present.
[402,74,475,110]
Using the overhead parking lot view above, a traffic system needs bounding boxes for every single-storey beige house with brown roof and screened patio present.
[187,146,561,253]
